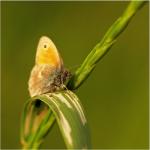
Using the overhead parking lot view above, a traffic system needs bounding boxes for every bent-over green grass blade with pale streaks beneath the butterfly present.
[21,90,91,149]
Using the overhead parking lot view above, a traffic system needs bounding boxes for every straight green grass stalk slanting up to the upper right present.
[67,1,146,90]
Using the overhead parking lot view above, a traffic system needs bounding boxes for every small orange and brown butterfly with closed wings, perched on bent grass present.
[28,36,71,97]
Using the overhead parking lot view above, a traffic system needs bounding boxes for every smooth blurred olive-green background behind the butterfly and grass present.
[1,1,149,149]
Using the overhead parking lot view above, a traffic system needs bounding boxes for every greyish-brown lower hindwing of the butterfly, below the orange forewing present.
[28,64,59,97]
